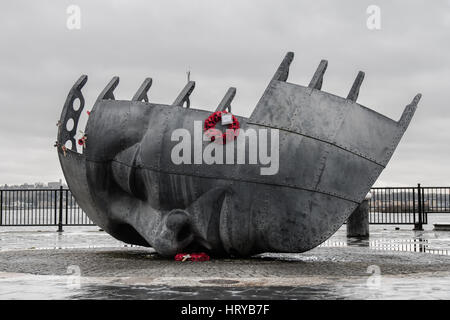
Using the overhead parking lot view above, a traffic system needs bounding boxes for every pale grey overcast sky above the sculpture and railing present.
[0,0,450,186]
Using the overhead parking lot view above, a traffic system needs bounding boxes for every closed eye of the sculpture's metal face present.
[111,144,146,200]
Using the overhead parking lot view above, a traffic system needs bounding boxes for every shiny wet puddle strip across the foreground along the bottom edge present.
[0,274,450,300]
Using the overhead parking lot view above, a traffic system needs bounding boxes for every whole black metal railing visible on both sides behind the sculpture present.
[0,184,450,231]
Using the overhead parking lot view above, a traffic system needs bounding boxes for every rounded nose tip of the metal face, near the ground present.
[154,209,194,256]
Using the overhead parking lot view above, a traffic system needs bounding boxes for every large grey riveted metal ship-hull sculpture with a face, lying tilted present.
[56,52,420,256]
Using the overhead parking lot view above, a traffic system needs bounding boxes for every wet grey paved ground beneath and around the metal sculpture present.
[0,216,450,299]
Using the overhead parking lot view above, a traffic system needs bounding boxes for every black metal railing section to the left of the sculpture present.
[0,187,94,231]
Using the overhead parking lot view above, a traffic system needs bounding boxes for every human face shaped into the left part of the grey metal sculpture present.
[85,101,239,256]
